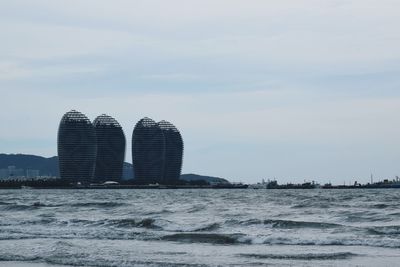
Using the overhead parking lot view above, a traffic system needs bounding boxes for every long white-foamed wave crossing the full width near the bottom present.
[0,229,400,248]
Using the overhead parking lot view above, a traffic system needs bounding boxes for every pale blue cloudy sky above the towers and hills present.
[0,0,400,184]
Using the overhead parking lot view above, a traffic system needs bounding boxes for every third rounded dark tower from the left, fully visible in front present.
[132,118,165,184]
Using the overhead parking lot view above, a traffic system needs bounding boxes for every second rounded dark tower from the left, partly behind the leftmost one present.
[93,114,125,182]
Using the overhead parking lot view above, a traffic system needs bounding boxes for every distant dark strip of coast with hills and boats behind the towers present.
[0,154,400,189]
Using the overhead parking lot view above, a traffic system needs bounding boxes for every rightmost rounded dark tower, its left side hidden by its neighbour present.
[158,120,183,184]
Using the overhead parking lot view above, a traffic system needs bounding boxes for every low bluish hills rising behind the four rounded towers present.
[0,154,229,184]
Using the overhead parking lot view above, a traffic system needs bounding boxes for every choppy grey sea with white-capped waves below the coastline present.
[0,189,400,267]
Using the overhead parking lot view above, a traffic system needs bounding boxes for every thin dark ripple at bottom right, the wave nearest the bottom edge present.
[239,252,359,260]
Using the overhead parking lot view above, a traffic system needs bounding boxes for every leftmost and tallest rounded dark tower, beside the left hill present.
[57,110,97,183]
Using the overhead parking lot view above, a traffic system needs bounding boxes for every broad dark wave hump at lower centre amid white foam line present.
[161,233,251,245]
